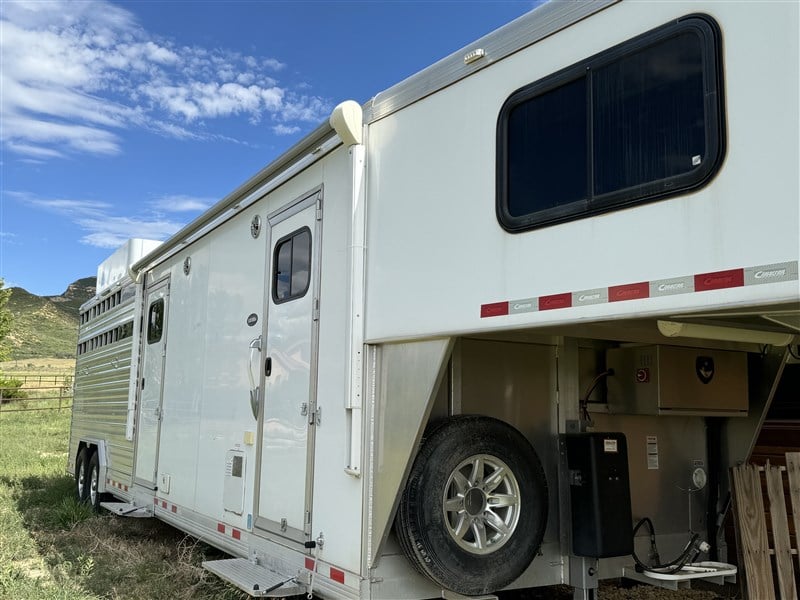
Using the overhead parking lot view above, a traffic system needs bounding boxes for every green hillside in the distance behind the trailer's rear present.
[5,277,96,360]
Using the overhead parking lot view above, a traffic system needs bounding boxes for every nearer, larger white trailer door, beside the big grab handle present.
[255,194,322,542]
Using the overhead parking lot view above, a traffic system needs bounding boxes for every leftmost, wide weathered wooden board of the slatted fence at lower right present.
[731,465,775,600]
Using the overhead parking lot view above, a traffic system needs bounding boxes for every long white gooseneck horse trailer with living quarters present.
[69,1,800,600]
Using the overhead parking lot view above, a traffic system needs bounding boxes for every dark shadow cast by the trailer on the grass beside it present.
[0,476,247,600]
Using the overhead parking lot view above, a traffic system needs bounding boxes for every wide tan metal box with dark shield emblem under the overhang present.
[606,346,748,416]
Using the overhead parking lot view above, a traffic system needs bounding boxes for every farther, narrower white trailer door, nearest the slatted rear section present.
[134,280,169,488]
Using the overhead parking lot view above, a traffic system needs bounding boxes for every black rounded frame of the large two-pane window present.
[495,14,726,233]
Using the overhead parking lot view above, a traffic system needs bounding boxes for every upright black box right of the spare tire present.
[566,432,633,558]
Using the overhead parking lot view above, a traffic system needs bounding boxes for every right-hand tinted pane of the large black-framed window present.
[592,33,706,196]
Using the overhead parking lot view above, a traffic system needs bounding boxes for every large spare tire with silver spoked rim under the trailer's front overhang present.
[395,416,548,596]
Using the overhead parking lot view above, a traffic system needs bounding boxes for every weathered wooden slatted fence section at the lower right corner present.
[731,452,800,600]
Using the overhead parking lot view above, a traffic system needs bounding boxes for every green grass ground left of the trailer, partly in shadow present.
[0,382,246,600]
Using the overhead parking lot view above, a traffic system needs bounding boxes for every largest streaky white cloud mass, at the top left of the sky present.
[0,0,331,160]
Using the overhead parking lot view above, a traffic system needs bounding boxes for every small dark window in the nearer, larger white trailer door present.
[272,227,311,304]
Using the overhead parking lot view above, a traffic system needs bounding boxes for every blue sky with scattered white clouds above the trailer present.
[0,0,535,295]
